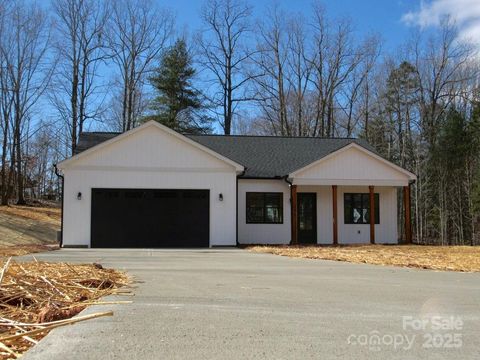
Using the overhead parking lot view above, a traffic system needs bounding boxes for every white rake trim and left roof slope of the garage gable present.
[57,120,244,172]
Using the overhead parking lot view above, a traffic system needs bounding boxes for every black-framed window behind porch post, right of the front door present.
[343,193,380,224]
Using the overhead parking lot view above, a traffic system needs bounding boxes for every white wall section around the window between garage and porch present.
[238,179,291,244]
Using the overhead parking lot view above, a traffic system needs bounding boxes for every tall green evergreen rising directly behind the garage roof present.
[145,39,211,134]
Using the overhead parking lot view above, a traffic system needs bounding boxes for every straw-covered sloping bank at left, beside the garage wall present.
[0,205,61,256]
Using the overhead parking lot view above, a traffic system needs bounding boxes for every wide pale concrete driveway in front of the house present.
[24,249,480,360]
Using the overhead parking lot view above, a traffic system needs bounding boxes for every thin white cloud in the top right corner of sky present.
[402,0,480,45]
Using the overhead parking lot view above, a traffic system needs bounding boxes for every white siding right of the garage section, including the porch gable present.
[238,144,415,244]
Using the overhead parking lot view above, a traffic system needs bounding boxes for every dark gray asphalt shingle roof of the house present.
[76,132,375,178]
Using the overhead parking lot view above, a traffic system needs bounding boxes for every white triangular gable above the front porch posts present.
[291,145,415,186]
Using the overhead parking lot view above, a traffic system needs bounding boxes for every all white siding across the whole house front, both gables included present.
[58,122,415,246]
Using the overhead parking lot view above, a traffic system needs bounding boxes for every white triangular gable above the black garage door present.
[61,122,239,171]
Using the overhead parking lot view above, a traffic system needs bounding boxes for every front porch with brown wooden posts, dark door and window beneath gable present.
[290,184,411,245]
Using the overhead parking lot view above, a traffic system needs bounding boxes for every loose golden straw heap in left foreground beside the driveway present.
[0,258,131,359]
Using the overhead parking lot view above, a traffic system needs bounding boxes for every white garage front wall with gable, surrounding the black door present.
[59,126,238,246]
